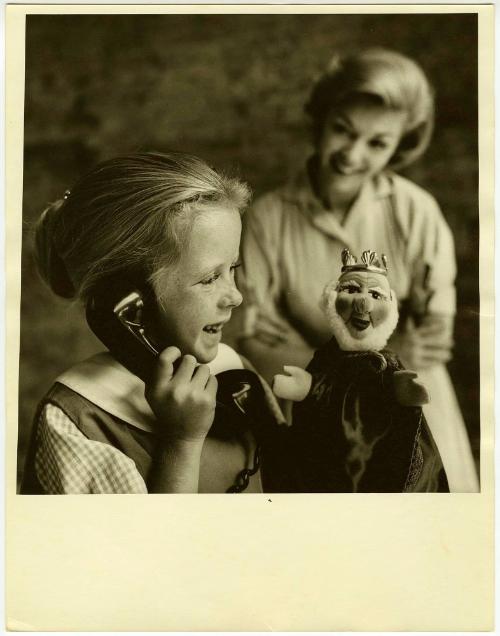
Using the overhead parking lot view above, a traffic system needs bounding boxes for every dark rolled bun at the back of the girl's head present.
[35,196,76,298]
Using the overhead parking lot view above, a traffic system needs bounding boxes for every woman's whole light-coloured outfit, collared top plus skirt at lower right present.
[238,172,479,492]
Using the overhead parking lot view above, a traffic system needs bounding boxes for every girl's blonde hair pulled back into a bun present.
[35,152,250,301]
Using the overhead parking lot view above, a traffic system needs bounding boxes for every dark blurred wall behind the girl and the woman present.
[18,9,479,486]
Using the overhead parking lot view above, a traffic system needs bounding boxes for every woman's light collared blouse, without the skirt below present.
[238,173,456,347]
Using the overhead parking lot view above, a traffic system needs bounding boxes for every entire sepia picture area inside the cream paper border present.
[18,8,480,494]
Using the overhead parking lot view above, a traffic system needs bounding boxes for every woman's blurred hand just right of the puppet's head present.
[389,315,453,371]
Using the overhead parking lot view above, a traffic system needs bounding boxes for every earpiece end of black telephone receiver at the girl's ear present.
[86,284,163,382]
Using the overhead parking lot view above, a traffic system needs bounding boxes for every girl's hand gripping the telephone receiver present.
[145,347,217,442]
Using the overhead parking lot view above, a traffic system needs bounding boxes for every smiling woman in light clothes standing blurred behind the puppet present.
[239,49,478,492]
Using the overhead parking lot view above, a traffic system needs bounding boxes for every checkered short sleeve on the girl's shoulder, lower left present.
[35,404,147,495]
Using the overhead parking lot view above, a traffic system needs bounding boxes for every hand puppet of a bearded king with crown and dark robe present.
[273,249,448,492]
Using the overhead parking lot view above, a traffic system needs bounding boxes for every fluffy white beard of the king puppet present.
[321,283,399,351]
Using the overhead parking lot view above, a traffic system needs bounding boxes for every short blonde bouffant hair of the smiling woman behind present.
[305,48,434,168]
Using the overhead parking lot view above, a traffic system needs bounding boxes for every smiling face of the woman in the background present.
[317,100,406,207]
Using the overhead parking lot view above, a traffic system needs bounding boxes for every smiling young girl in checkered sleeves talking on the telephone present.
[22,153,284,494]
